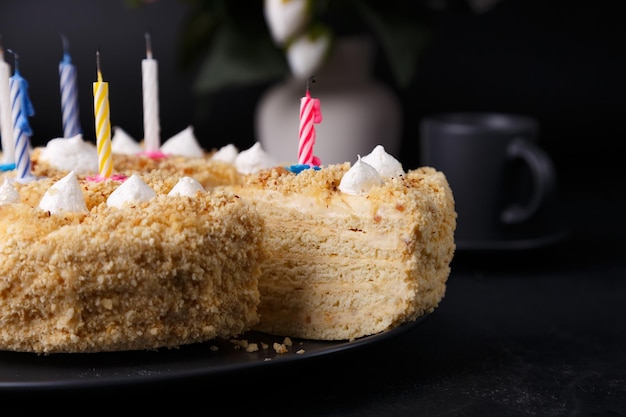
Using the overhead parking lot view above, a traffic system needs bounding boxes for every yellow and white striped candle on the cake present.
[93,51,113,178]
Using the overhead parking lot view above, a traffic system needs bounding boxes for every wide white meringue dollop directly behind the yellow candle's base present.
[41,134,98,174]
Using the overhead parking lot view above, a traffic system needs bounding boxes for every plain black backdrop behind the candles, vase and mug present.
[0,0,626,190]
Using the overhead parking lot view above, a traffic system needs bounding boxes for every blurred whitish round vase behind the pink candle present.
[255,37,403,165]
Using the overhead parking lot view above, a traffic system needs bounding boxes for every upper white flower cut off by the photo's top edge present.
[263,0,311,46]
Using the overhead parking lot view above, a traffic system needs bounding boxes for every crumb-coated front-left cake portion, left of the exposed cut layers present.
[0,170,265,353]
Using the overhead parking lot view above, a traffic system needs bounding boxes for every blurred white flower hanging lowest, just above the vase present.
[287,31,331,79]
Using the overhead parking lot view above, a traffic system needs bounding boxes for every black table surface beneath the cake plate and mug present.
[0,178,626,416]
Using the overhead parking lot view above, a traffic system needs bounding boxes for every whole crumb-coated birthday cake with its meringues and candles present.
[0,37,448,354]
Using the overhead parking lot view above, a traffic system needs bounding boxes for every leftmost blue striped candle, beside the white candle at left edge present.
[9,51,35,182]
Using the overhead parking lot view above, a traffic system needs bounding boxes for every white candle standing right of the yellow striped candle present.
[141,33,161,153]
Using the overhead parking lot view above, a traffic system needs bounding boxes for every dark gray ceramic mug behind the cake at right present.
[420,113,556,249]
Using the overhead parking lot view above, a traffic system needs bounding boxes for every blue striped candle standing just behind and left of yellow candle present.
[59,36,82,138]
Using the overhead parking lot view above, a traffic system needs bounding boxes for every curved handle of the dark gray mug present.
[500,138,556,224]
